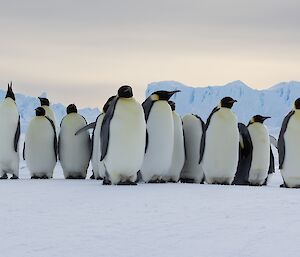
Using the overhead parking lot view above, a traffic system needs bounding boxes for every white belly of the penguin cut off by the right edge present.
[281,112,300,187]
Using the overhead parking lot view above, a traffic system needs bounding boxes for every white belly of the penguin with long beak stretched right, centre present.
[141,101,174,182]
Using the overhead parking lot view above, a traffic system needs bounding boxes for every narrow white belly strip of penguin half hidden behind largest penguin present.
[91,114,105,179]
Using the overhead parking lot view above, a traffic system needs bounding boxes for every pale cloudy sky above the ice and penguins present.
[0,0,300,107]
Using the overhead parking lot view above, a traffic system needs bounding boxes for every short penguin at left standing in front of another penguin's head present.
[23,107,57,179]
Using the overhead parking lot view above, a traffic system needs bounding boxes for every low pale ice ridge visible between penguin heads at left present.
[0,90,99,133]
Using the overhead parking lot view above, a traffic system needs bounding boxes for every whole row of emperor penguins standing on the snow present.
[0,83,300,188]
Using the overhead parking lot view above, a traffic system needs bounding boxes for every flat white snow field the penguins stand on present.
[0,158,300,257]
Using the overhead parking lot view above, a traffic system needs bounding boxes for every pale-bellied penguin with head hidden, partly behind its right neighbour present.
[180,114,205,183]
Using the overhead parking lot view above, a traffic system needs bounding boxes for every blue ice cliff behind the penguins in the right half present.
[146,80,300,134]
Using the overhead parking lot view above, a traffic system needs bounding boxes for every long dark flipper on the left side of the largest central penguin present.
[100,96,119,161]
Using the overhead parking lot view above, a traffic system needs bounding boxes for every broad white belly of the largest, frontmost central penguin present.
[104,98,146,184]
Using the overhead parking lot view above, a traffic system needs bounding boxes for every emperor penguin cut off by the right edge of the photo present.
[277,98,300,188]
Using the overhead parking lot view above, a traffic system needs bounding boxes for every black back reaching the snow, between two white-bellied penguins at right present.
[232,123,253,185]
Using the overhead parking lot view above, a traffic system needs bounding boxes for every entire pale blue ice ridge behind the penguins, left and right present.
[0,81,300,133]
